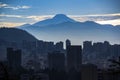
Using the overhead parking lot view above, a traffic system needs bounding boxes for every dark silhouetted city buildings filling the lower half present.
[0,34,120,80]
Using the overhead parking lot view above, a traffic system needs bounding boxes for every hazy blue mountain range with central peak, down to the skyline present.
[20,14,120,43]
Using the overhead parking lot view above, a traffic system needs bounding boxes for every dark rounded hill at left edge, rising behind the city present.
[0,28,37,42]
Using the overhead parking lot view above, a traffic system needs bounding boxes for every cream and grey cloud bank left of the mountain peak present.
[0,14,52,27]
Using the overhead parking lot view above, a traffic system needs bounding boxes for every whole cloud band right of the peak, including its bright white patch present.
[69,13,120,26]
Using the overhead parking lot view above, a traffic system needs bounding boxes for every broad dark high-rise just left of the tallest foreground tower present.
[48,52,65,71]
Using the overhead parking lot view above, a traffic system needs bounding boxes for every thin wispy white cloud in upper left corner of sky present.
[0,2,31,10]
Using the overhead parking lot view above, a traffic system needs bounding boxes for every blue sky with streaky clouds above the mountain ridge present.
[0,0,120,27]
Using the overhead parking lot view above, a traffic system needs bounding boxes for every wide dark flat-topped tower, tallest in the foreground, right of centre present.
[66,45,82,71]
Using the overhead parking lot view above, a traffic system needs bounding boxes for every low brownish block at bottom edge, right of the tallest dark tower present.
[81,64,98,80]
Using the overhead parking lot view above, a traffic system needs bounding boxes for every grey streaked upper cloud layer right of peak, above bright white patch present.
[69,13,120,22]
